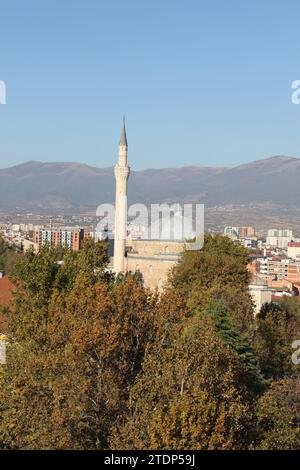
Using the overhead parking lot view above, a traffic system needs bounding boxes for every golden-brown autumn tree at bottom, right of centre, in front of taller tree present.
[110,315,253,449]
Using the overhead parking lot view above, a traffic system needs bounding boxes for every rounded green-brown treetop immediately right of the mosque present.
[169,235,253,331]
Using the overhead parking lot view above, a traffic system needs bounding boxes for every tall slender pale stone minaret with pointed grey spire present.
[114,118,130,274]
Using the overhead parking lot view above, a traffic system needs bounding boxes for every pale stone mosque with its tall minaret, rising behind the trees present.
[113,120,194,290]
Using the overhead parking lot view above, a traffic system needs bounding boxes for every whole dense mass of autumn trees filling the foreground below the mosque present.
[0,236,300,449]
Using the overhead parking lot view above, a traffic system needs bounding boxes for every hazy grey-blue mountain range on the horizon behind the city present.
[0,156,300,213]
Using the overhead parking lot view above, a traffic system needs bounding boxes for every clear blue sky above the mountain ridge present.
[0,0,300,169]
